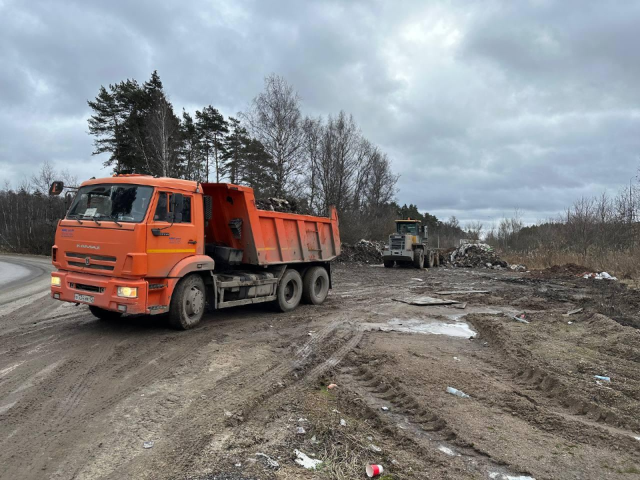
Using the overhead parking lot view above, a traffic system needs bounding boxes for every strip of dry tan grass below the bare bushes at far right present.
[502,249,640,280]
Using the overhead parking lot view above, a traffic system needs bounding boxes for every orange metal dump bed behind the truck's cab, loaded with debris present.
[202,183,340,265]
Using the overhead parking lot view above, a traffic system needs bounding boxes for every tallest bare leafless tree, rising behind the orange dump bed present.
[242,74,304,196]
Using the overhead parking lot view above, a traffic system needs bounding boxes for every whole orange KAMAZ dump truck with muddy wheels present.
[51,175,340,329]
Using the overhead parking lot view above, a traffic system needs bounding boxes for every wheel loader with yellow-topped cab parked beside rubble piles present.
[382,218,436,269]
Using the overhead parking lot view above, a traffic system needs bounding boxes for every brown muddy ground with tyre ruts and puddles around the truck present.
[0,253,640,480]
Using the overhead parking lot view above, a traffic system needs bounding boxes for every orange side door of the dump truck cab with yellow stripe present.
[147,191,198,277]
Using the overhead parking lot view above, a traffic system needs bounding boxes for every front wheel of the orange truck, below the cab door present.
[169,274,206,330]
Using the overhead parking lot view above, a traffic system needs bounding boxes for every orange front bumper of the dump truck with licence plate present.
[51,271,149,313]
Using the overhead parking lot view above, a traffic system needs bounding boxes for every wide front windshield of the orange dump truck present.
[67,184,153,223]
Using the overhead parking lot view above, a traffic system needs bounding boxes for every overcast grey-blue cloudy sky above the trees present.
[0,0,640,225]
